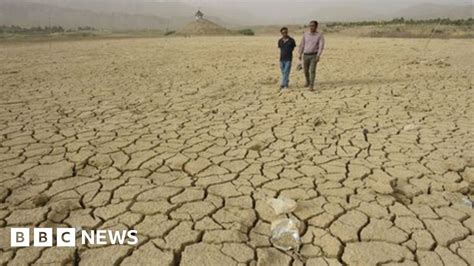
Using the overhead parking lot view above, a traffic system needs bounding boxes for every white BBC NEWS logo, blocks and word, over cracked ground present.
[10,228,138,247]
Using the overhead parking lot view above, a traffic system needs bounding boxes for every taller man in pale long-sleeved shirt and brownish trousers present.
[299,20,324,90]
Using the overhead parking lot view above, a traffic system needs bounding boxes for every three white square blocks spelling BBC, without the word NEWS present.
[10,228,76,247]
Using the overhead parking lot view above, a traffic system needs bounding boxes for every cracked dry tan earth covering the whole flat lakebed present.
[0,35,474,266]
